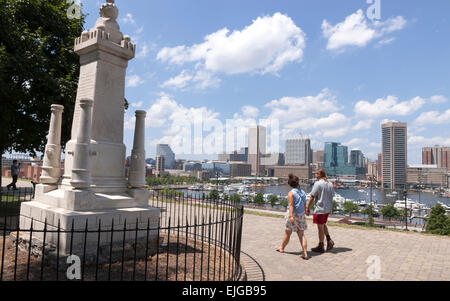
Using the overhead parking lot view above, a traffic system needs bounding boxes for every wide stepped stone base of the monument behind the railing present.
[20,185,160,255]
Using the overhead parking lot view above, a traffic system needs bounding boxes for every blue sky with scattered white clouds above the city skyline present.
[82,0,450,164]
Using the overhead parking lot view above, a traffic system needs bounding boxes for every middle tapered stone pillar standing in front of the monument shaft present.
[70,98,94,189]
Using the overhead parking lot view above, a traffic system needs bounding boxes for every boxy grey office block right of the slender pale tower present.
[284,137,312,165]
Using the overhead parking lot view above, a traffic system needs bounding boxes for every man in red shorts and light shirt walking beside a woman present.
[306,169,334,253]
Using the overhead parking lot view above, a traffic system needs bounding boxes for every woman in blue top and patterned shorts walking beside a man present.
[276,174,309,260]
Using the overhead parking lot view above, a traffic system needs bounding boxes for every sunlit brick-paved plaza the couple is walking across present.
[242,214,450,281]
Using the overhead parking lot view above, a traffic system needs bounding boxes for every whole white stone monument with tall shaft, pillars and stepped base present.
[20,0,160,253]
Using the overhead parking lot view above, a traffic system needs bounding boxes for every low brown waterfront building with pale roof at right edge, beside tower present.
[407,164,448,187]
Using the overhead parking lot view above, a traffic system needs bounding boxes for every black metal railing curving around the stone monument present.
[0,192,244,281]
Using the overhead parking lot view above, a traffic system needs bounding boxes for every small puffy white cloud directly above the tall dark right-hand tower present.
[354,95,425,118]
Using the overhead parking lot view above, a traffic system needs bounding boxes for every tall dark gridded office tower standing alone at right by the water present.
[381,122,408,189]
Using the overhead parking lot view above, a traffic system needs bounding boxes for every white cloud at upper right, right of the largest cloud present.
[322,9,406,50]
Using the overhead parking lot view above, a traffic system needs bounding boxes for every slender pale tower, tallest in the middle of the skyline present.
[248,125,267,176]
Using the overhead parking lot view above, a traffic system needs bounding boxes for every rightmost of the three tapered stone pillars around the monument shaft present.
[128,111,147,188]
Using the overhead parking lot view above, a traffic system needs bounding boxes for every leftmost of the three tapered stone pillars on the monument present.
[41,105,64,185]
